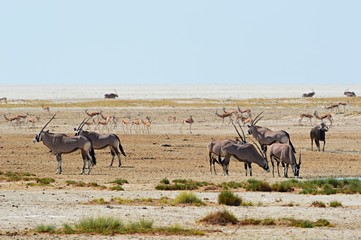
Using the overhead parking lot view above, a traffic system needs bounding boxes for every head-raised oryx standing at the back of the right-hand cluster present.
[247,112,296,154]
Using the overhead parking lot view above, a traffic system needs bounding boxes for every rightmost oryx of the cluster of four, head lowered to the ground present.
[269,143,301,178]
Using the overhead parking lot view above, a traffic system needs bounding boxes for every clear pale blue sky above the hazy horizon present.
[0,0,361,84]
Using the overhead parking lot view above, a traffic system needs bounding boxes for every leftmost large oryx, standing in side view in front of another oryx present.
[33,114,96,174]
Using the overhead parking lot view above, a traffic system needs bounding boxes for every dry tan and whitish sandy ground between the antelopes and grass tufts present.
[0,99,361,239]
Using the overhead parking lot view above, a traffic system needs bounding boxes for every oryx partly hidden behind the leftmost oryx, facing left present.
[74,119,126,167]
